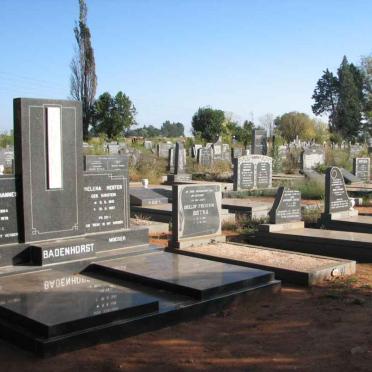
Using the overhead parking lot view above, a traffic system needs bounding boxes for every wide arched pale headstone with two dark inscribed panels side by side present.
[233,155,272,191]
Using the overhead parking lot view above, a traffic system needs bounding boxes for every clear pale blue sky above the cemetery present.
[0,0,372,134]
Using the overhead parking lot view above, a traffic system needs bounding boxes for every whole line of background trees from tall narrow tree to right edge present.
[70,0,372,146]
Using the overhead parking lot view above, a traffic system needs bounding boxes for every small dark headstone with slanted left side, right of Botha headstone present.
[269,186,301,224]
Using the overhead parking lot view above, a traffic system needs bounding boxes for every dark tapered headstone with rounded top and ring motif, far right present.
[324,167,351,214]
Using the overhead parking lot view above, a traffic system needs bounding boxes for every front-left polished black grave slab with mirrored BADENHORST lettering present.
[0,270,159,337]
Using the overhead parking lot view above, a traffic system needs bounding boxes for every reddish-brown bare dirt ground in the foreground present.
[0,240,372,372]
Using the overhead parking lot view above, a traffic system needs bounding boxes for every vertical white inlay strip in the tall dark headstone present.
[46,107,62,189]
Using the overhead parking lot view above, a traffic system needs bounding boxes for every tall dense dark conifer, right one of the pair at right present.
[334,57,364,139]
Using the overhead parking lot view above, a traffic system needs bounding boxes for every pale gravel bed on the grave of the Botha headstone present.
[182,243,340,272]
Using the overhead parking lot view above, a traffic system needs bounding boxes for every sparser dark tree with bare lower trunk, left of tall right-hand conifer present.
[311,69,339,130]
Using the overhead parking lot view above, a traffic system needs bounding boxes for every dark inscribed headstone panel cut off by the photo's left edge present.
[0,176,18,246]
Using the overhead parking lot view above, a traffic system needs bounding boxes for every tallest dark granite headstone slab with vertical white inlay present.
[14,98,84,242]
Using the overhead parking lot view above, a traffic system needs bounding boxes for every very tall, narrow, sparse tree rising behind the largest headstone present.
[70,0,97,139]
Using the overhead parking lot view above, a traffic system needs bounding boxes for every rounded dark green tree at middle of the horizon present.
[191,107,225,141]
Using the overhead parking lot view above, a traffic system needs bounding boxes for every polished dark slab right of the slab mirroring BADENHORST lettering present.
[86,252,273,300]
